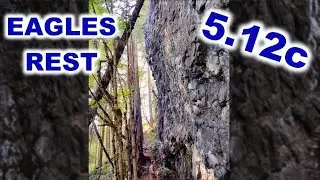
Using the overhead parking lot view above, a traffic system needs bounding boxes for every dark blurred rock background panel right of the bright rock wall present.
[229,0,320,180]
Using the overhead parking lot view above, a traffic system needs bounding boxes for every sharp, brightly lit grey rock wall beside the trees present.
[145,0,229,179]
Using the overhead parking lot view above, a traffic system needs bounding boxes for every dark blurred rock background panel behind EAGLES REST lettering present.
[0,0,88,180]
